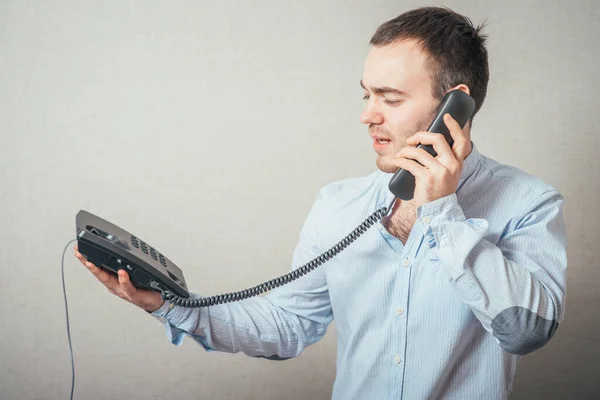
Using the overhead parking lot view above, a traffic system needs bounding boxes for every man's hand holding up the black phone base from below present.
[75,244,164,312]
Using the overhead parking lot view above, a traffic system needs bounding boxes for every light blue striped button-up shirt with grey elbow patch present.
[153,142,567,400]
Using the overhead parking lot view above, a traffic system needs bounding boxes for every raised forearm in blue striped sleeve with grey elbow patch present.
[440,231,562,354]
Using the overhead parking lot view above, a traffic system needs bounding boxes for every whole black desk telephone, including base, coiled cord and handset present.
[76,90,475,307]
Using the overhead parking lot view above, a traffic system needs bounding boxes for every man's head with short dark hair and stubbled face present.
[361,7,489,172]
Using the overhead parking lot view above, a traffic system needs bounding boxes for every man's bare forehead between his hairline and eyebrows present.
[363,39,431,93]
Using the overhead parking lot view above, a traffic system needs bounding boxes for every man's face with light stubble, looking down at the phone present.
[361,40,439,173]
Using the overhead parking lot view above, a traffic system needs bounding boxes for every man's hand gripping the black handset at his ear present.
[394,114,471,207]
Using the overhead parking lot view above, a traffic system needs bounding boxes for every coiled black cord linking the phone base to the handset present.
[158,198,396,308]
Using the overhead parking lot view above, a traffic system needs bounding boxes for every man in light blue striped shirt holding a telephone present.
[76,7,566,400]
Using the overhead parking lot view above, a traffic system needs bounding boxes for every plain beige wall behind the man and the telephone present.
[0,0,600,400]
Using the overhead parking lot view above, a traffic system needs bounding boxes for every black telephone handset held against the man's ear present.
[388,89,475,201]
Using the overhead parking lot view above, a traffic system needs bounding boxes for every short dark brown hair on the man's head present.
[370,7,489,124]
